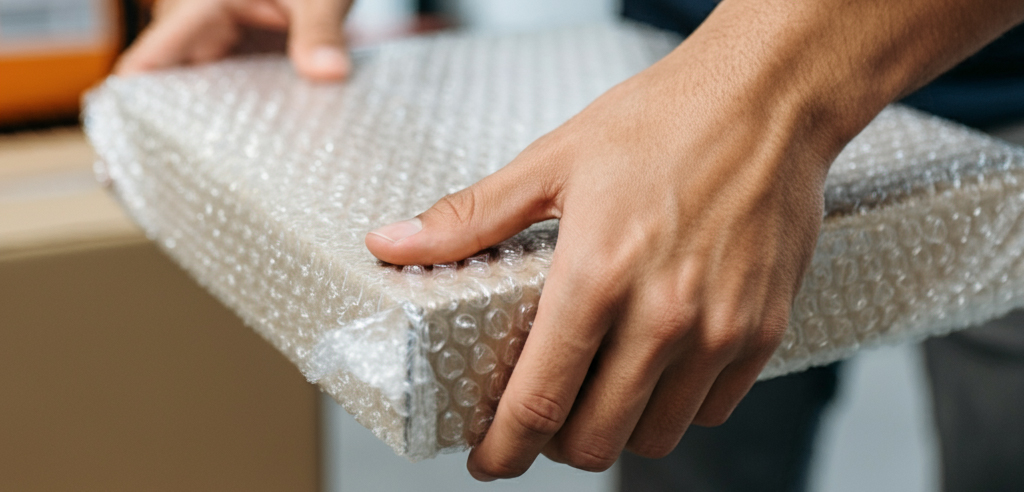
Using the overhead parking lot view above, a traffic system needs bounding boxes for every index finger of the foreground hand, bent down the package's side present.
[467,243,609,481]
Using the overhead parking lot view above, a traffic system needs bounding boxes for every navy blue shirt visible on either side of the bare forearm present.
[623,0,1024,127]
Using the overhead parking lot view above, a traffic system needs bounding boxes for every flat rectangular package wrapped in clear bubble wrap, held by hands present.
[85,25,1024,459]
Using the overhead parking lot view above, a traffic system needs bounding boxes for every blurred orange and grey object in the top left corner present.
[0,0,122,126]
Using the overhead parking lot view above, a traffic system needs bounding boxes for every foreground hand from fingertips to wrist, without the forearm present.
[367,10,842,480]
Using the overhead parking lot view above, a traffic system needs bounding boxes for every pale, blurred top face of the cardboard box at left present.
[0,127,145,260]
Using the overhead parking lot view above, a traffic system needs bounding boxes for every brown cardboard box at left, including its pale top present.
[0,130,319,491]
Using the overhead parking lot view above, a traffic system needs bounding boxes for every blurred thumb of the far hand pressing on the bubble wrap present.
[288,0,352,81]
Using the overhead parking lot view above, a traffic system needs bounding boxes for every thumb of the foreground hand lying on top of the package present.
[366,162,558,264]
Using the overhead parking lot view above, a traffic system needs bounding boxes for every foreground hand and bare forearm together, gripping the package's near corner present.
[367,0,1024,480]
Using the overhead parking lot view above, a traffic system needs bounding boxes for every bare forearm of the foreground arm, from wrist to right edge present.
[659,0,1024,153]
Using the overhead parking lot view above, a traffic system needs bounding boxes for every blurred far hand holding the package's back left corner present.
[115,0,352,81]
